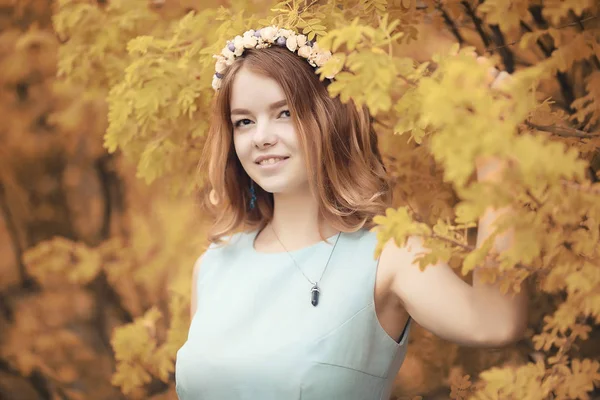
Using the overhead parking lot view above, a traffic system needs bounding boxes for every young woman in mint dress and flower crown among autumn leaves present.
[176,27,525,400]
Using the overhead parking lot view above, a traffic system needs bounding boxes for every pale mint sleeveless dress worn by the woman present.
[175,229,411,400]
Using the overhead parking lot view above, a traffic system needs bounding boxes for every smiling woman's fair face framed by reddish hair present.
[231,67,308,193]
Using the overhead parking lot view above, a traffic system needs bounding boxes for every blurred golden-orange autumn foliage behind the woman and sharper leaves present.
[0,0,600,400]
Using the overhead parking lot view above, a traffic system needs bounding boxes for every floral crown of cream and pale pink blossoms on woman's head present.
[212,25,334,91]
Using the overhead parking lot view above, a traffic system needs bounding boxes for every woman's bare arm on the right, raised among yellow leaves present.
[382,161,527,347]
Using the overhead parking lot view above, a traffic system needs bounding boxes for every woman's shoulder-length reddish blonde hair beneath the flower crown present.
[199,46,392,244]
